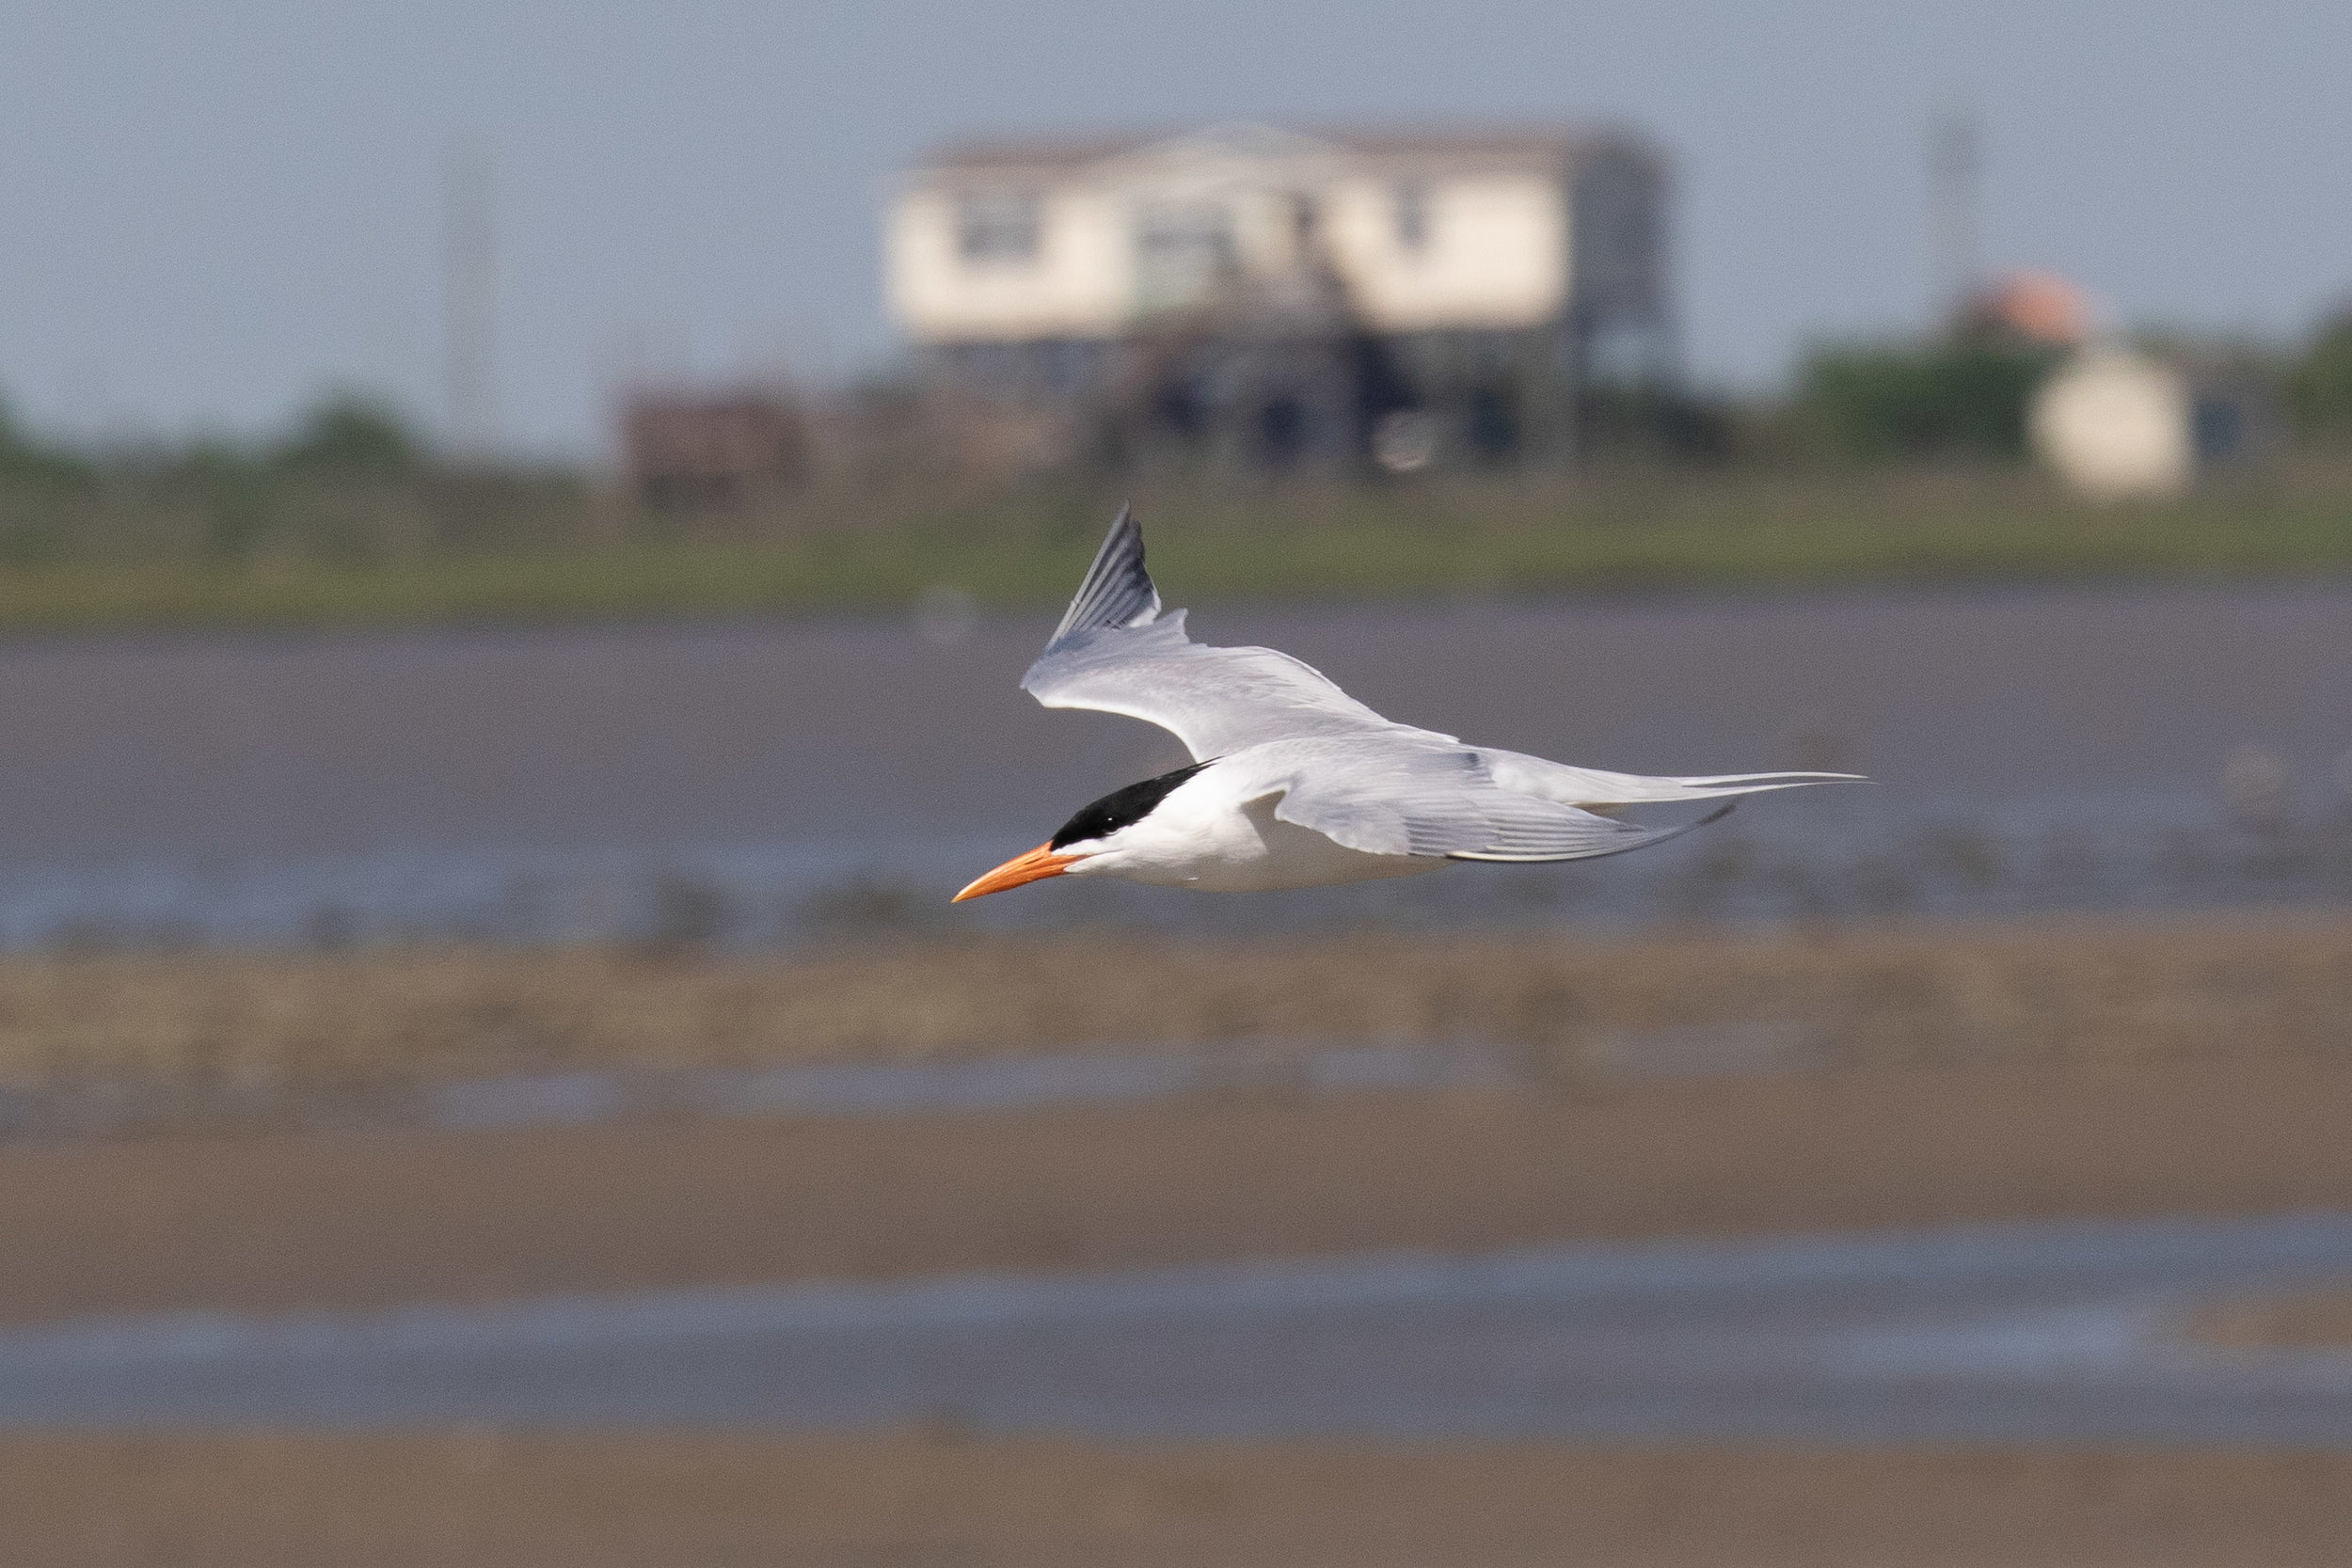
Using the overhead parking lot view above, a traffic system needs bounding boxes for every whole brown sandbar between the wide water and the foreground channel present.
[0,917,2352,1322]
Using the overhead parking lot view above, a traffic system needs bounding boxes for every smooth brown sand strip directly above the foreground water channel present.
[0,1043,2352,1322]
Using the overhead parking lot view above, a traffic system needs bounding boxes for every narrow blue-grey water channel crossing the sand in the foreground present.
[13,1215,2352,1446]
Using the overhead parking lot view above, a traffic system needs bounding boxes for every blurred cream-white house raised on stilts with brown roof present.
[884,124,1673,463]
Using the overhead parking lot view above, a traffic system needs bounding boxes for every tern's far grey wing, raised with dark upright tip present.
[1021,508,1452,762]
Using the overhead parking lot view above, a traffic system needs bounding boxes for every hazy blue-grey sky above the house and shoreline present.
[0,0,2352,451]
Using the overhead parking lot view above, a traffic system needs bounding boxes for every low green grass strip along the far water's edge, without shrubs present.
[0,470,2352,632]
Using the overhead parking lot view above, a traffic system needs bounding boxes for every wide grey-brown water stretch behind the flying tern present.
[0,583,2352,947]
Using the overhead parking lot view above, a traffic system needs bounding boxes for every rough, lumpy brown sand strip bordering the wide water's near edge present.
[0,910,2352,1088]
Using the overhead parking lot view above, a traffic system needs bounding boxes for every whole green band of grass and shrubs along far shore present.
[0,338,2352,632]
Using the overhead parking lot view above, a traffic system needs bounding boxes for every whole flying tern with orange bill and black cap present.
[955,508,1853,903]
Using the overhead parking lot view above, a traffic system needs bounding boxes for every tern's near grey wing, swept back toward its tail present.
[1270,743,1739,863]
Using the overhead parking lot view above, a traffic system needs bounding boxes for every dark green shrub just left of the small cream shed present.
[1797,339,2058,461]
